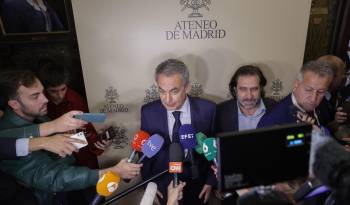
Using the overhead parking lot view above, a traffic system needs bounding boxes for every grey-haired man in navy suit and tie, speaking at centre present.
[141,59,216,205]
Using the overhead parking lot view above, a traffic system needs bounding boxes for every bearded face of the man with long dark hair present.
[236,75,261,110]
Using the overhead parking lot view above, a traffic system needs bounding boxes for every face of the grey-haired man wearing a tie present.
[157,74,190,110]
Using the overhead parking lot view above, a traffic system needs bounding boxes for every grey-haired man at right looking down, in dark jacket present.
[258,61,334,127]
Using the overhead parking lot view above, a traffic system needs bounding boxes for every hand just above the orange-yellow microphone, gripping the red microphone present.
[111,158,142,179]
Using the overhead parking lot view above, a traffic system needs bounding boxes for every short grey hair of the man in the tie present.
[154,59,190,85]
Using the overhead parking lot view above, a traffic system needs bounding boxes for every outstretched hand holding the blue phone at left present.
[40,111,87,136]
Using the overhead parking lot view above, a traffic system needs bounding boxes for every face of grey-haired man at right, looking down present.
[293,71,331,112]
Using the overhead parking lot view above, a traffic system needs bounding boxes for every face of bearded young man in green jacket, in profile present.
[9,79,48,120]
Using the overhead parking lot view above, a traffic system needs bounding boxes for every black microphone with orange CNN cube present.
[169,143,184,187]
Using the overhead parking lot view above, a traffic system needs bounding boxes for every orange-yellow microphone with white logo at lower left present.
[90,171,120,205]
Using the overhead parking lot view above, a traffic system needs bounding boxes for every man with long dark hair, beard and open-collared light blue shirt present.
[215,65,276,133]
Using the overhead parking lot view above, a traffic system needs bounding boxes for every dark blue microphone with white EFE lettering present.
[179,124,199,179]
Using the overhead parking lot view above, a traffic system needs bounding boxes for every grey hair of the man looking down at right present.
[297,60,334,82]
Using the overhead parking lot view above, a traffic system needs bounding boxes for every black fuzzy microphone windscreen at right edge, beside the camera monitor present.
[313,140,350,186]
